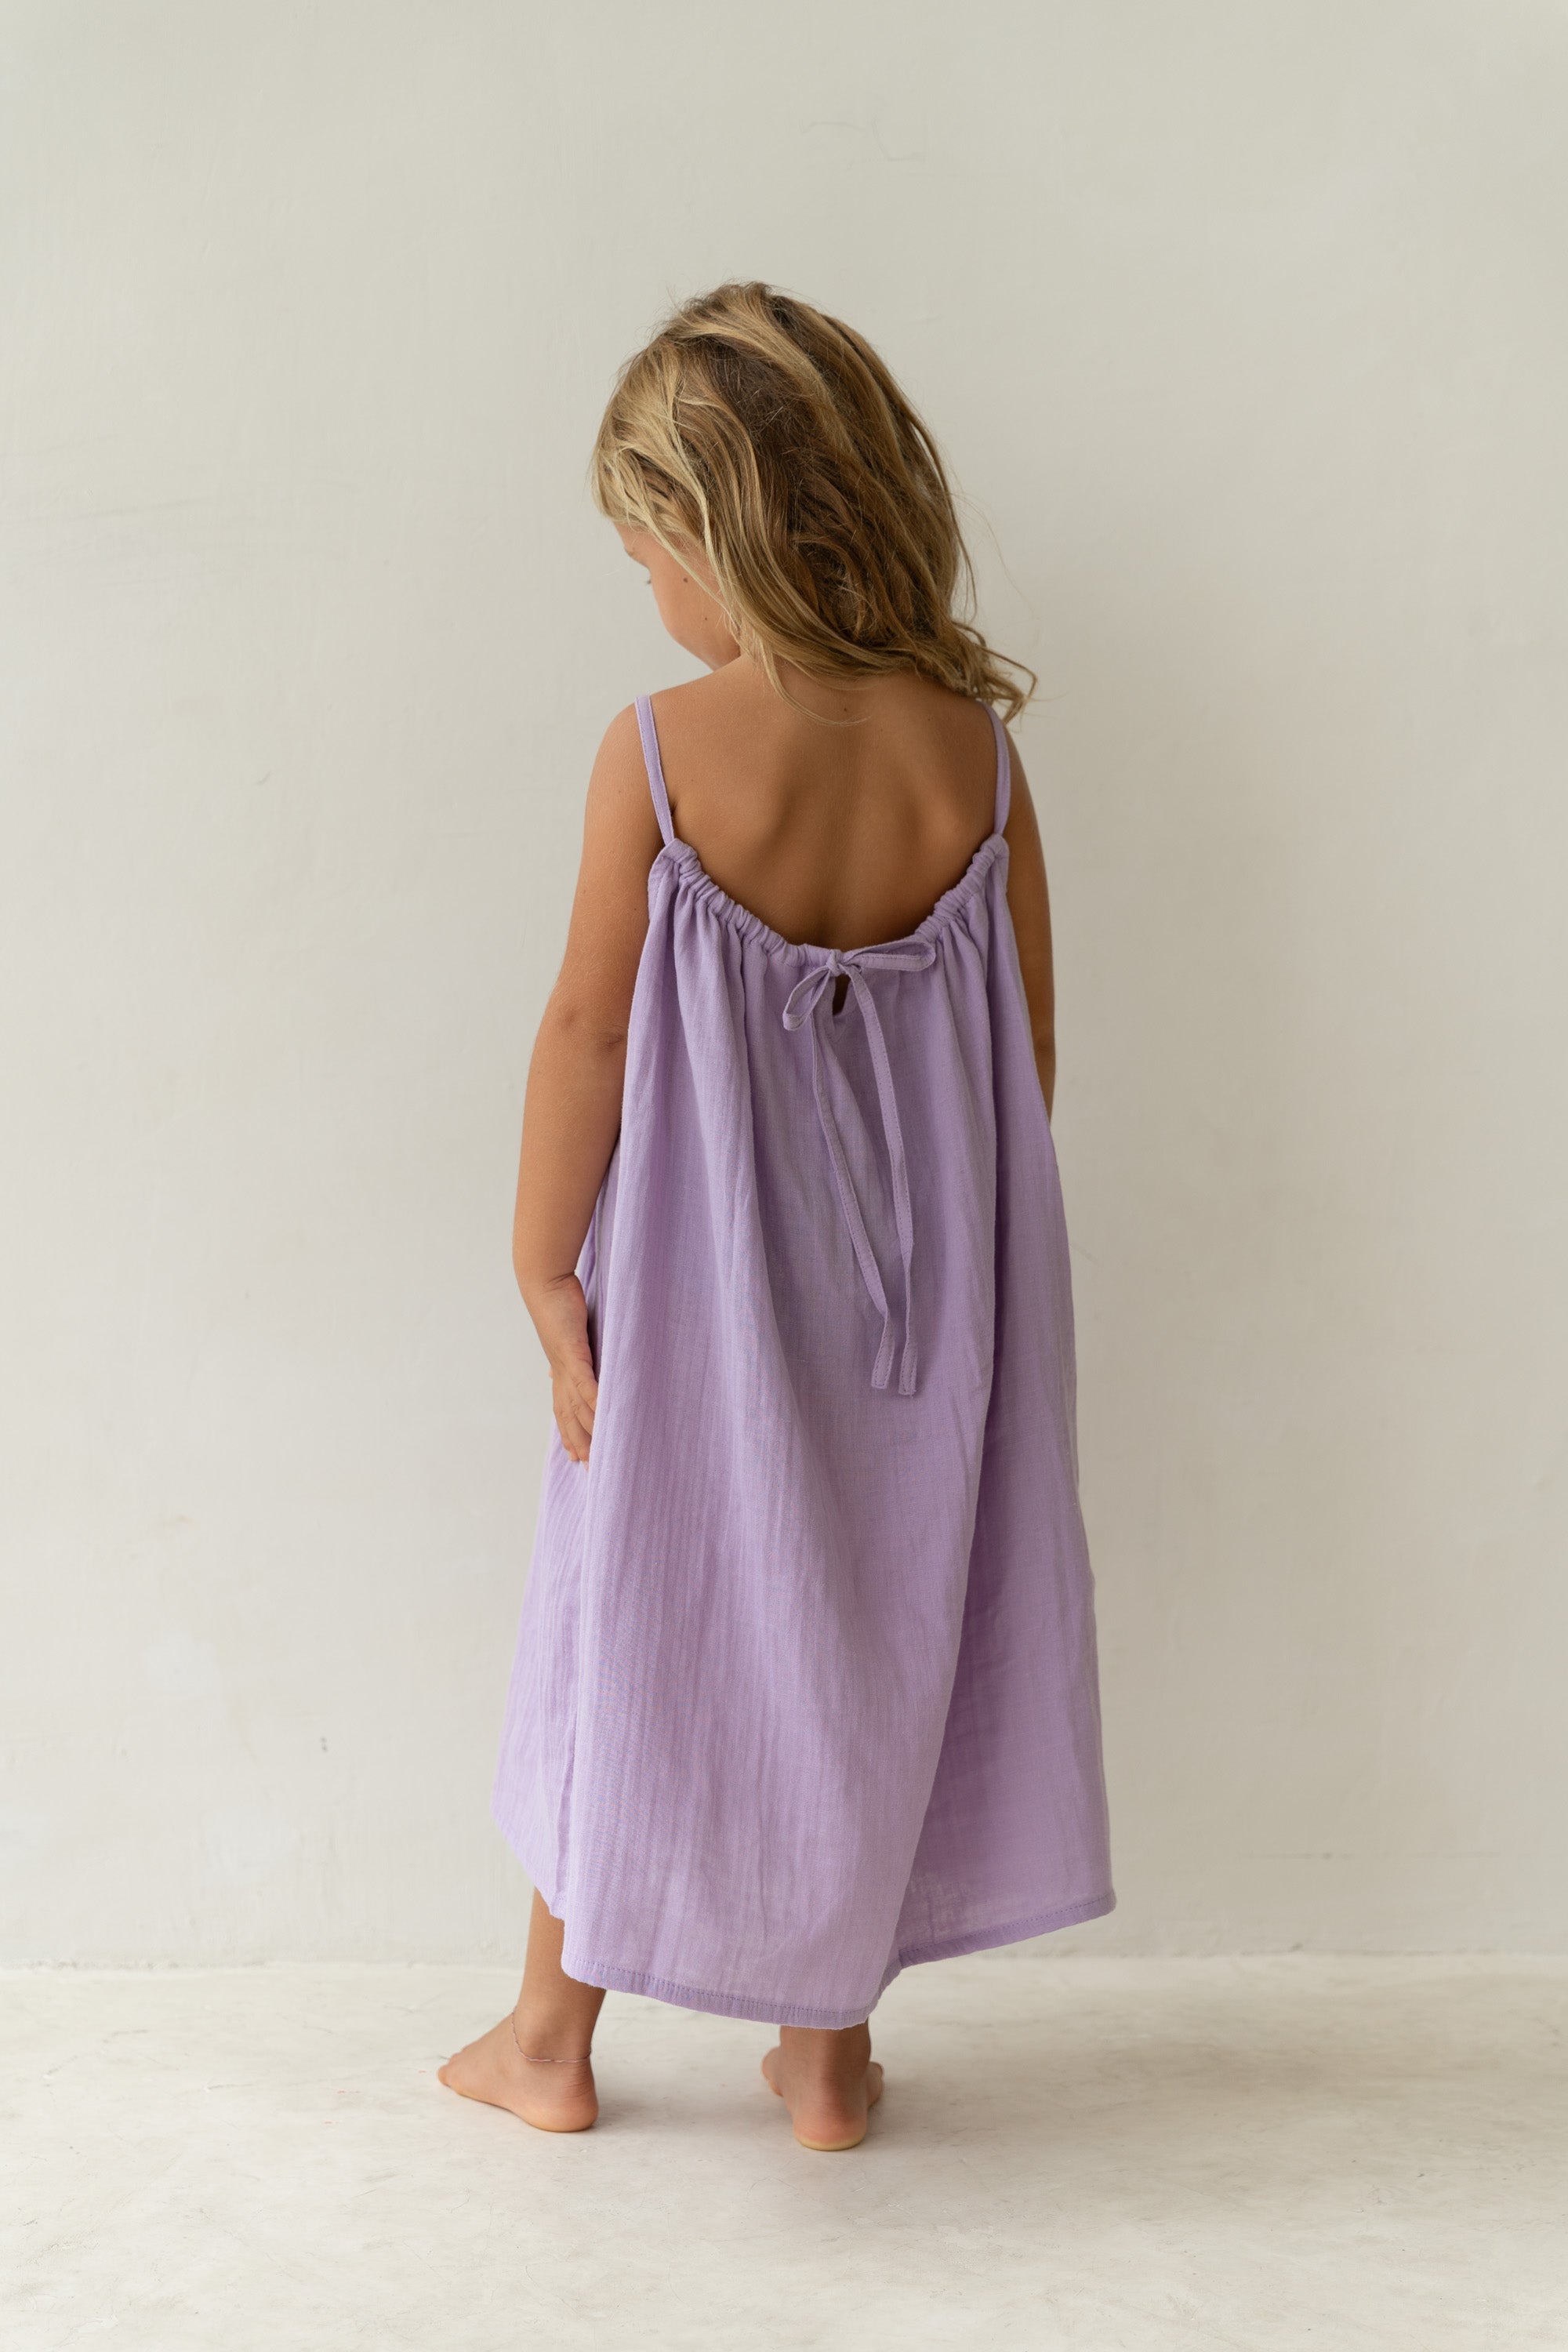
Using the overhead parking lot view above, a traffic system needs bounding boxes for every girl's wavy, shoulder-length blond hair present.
[590,282,1036,720]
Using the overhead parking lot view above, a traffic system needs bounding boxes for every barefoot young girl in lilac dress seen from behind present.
[442,285,1114,2150]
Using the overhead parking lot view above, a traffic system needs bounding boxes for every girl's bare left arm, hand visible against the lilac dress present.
[513,710,661,1463]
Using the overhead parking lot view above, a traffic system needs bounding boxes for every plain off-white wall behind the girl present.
[0,0,1568,1962]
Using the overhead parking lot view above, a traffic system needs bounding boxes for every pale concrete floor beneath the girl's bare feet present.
[0,1955,1568,2352]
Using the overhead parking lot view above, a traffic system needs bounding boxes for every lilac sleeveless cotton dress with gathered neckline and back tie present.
[494,699,1114,2027]
